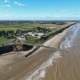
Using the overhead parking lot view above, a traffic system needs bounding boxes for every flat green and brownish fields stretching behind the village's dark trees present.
[0,22,74,31]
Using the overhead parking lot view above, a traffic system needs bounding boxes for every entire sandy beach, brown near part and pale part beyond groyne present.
[0,24,71,80]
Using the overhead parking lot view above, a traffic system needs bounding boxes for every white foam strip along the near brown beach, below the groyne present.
[25,51,61,80]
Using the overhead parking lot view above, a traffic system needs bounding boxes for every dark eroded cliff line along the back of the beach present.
[0,23,76,54]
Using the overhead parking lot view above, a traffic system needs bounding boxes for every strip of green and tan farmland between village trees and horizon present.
[0,22,74,30]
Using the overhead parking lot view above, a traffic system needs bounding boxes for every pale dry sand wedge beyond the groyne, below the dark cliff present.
[44,26,72,48]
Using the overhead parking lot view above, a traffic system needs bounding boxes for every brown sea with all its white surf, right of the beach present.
[25,24,80,80]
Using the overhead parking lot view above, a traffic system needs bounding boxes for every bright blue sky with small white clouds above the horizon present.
[0,0,80,20]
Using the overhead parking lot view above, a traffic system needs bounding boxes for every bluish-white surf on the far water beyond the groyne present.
[60,24,80,49]
